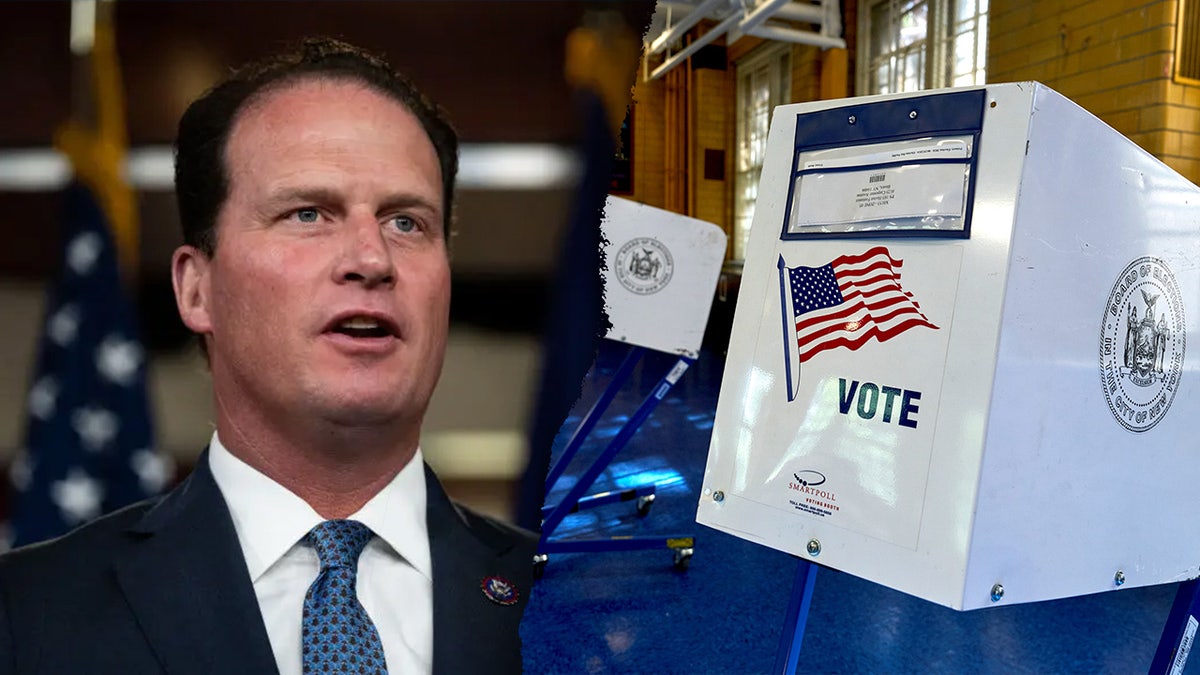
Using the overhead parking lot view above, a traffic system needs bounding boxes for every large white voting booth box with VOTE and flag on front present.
[697,83,1200,609]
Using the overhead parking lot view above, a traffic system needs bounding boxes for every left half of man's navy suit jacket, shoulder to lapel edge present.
[0,455,276,675]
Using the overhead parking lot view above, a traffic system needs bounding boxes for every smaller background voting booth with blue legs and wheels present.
[534,197,725,577]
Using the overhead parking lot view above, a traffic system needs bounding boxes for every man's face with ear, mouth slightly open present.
[175,79,450,443]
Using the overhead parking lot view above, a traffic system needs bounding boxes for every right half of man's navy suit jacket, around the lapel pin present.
[425,466,535,674]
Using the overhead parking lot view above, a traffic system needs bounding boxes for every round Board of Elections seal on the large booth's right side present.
[1100,252,1186,432]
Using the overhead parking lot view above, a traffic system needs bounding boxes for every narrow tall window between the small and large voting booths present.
[733,44,792,261]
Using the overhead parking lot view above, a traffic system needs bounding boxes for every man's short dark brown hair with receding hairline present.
[175,37,458,257]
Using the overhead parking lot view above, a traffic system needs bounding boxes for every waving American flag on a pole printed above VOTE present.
[779,246,937,400]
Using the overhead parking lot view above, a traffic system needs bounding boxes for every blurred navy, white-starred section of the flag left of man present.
[0,183,174,550]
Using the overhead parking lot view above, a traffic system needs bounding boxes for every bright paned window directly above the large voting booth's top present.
[858,0,988,94]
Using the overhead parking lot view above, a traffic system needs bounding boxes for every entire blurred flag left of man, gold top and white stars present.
[0,5,174,550]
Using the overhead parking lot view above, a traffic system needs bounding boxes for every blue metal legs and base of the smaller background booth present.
[538,346,696,554]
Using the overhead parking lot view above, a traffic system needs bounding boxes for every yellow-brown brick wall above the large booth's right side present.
[988,0,1200,181]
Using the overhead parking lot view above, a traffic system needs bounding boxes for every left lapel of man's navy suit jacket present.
[115,452,276,675]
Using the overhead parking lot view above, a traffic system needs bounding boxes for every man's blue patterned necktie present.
[301,520,388,675]
